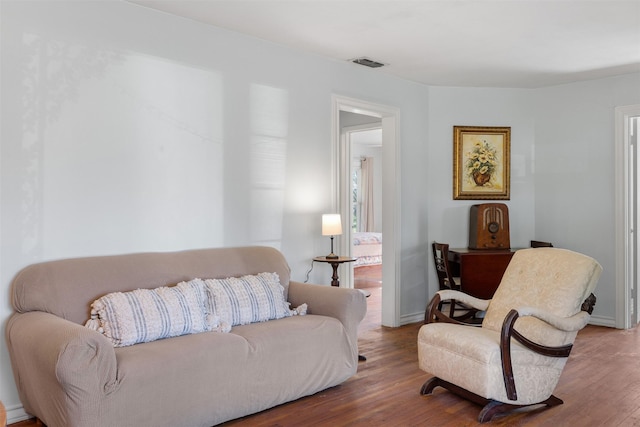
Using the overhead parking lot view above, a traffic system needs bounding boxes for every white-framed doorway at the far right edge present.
[615,105,640,329]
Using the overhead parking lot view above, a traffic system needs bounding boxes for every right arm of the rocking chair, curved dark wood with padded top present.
[500,294,596,400]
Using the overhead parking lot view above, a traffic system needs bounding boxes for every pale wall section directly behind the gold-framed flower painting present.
[423,87,536,284]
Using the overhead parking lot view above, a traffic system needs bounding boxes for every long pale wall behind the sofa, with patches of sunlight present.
[0,1,428,421]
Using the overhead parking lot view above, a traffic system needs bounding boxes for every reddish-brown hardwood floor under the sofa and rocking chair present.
[13,286,640,427]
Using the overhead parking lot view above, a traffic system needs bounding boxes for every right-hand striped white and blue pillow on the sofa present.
[204,273,294,326]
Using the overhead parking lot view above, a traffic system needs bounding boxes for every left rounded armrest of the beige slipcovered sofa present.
[6,311,118,423]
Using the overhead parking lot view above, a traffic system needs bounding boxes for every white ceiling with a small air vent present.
[130,0,640,88]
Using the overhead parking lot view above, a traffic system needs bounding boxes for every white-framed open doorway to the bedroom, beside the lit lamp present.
[332,96,401,327]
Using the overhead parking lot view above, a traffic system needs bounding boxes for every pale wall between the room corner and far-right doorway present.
[535,73,640,326]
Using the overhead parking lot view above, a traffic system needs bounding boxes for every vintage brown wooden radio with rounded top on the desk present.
[469,203,511,249]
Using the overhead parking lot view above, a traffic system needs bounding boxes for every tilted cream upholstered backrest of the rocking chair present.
[482,248,602,346]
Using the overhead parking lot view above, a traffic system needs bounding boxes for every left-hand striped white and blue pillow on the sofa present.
[86,281,213,347]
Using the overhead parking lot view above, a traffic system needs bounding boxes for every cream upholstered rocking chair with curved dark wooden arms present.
[418,248,602,423]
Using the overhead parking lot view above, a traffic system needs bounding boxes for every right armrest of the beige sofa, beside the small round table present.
[288,281,367,343]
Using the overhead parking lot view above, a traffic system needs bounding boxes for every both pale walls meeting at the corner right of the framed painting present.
[428,73,640,326]
